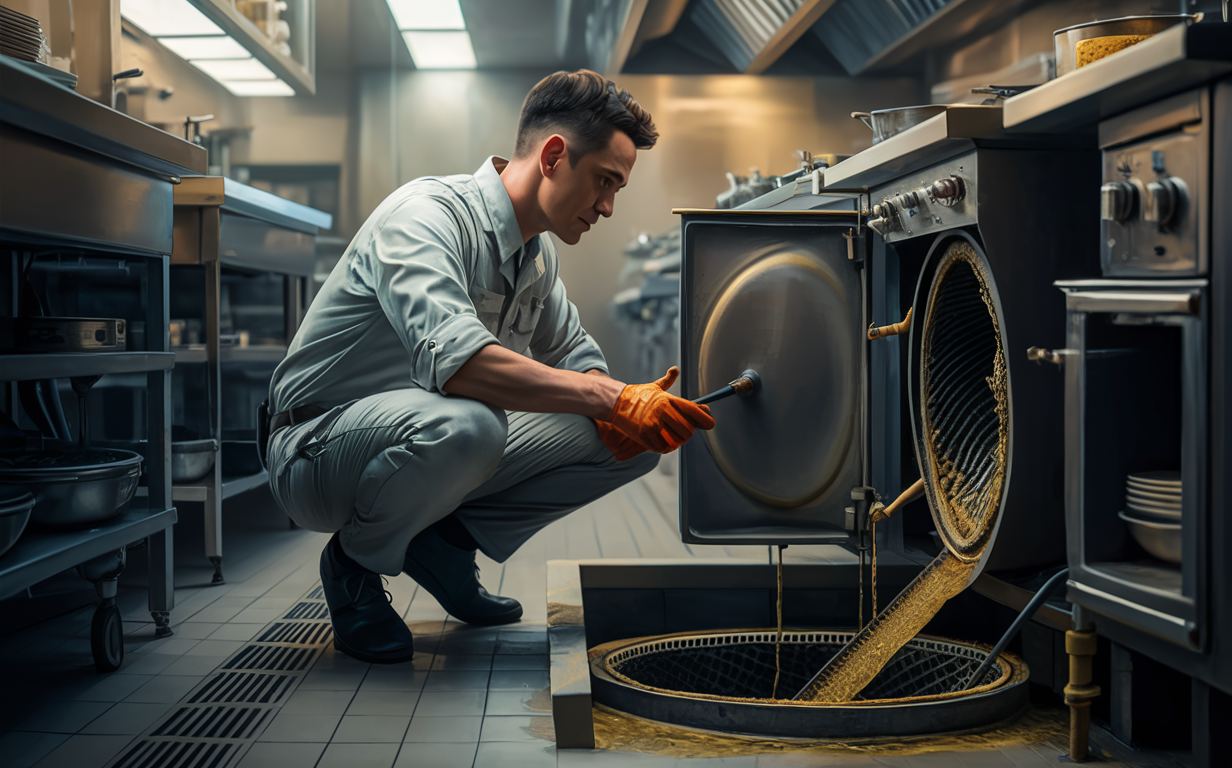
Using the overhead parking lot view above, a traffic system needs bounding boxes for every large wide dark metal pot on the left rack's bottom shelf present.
[0,449,142,526]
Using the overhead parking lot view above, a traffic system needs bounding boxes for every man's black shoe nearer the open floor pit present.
[402,528,522,624]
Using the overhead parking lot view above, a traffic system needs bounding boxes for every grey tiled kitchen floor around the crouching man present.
[0,458,1170,768]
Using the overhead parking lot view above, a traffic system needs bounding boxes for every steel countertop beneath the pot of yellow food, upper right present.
[1004,22,1232,133]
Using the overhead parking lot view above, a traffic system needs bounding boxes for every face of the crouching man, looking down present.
[540,131,637,245]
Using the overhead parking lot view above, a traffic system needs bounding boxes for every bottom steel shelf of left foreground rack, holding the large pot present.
[0,504,176,598]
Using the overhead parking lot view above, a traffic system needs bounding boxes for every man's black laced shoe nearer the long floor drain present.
[320,534,415,664]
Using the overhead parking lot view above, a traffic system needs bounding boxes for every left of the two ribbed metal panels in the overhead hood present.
[690,0,833,74]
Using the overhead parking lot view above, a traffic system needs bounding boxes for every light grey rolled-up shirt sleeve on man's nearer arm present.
[372,197,498,392]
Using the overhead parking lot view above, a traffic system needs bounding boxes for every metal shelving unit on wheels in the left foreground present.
[0,57,206,672]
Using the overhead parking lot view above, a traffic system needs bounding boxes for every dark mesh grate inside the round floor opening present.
[607,632,1003,700]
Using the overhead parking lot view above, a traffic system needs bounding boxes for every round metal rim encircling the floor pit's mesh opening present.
[586,627,1030,710]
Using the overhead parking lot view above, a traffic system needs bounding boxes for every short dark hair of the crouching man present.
[514,69,659,165]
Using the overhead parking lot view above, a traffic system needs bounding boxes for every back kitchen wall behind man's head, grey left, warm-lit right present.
[356,71,923,377]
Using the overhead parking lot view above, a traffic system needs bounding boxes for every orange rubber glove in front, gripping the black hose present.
[607,366,715,454]
